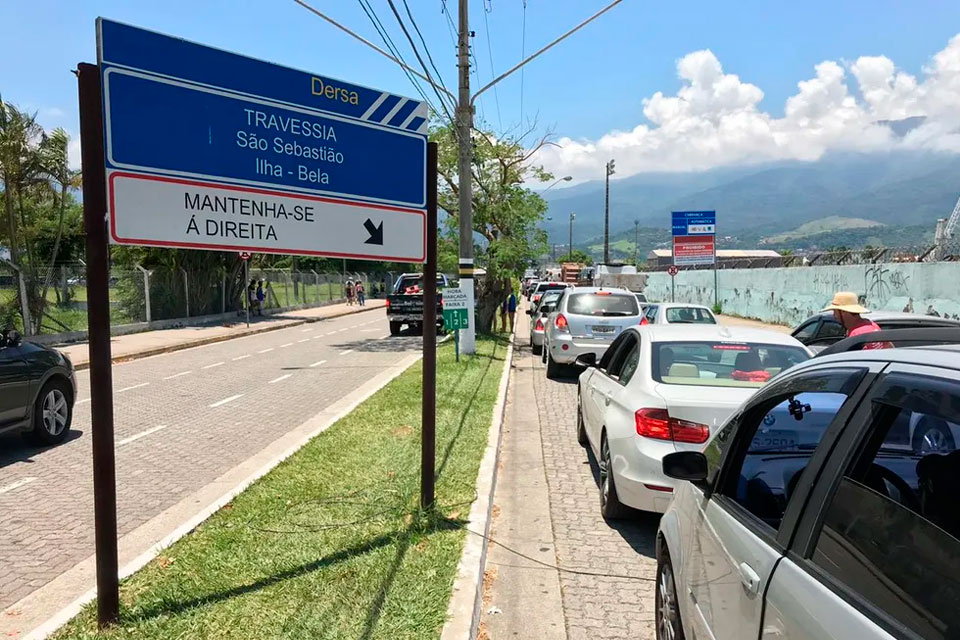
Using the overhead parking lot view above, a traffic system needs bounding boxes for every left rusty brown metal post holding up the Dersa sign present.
[77,64,120,629]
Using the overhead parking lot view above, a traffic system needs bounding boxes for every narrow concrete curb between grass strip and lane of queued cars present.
[440,331,516,640]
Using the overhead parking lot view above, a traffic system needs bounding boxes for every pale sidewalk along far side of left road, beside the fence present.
[57,300,386,369]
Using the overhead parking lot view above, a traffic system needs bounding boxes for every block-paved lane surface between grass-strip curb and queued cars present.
[481,308,658,640]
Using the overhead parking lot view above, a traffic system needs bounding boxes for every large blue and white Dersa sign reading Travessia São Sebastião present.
[97,19,427,262]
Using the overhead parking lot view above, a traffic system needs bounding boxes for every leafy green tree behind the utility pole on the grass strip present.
[430,124,553,331]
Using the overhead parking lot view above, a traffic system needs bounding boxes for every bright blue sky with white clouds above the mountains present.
[0,0,960,186]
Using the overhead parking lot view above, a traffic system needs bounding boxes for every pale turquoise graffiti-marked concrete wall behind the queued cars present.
[646,262,960,325]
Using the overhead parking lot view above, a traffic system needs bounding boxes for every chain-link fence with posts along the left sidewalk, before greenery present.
[0,262,399,335]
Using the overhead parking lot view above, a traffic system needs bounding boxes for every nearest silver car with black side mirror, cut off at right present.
[655,342,960,640]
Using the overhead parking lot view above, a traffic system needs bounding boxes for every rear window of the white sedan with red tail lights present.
[651,341,810,387]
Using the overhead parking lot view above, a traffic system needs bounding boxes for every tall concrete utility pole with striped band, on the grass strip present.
[456,0,477,354]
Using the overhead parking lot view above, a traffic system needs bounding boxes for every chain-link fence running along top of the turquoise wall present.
[646,240,960,271]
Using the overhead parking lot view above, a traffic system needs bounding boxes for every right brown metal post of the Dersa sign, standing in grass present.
[420,142,437,510]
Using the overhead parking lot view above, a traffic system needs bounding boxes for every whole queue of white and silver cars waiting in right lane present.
[531,287,960,640]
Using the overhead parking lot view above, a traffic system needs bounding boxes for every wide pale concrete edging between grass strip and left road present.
[6,353,423,640]
